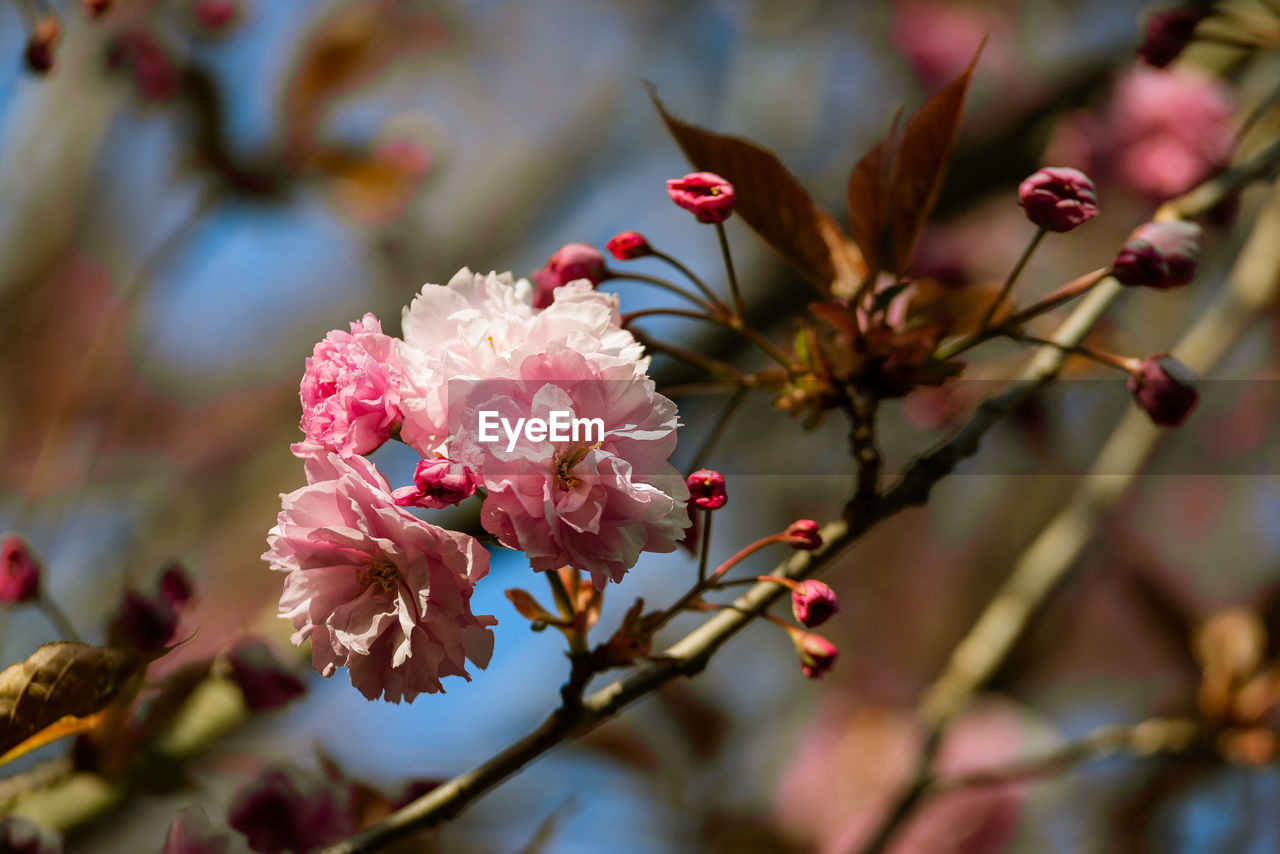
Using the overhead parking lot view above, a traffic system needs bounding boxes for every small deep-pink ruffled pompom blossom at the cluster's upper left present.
[291,314,401,457]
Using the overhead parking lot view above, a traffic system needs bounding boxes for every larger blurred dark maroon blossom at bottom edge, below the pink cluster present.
[227,766,355,854]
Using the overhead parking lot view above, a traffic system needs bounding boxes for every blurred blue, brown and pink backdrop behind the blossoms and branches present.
[0,0,1280,854]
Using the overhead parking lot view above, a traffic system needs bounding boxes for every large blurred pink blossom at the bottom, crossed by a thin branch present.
[776,700,1028,854]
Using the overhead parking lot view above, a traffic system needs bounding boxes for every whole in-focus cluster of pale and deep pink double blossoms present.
[264,265,690,702]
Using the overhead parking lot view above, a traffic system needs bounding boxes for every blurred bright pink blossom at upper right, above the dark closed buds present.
[1044,65,1235,201]
